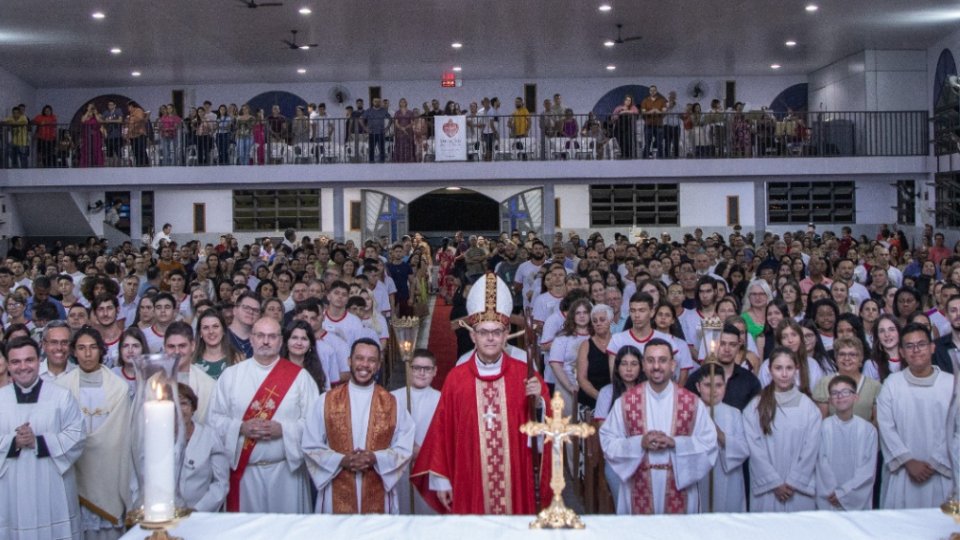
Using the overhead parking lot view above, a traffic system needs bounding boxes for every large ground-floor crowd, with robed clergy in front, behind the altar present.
[0,219,960,539]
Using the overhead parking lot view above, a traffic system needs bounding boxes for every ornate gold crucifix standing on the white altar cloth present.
[520,392,597,529]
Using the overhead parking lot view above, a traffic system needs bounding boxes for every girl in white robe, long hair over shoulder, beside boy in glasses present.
[743,347,822,512]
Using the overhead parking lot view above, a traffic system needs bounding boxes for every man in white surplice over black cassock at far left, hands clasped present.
[0,337,86,540]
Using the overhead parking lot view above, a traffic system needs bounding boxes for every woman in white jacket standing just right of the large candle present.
[177,383,230,512]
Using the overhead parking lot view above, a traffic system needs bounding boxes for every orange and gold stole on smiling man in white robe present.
[323,384,397,514]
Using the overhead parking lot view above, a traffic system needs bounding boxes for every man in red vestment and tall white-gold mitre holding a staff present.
[410,273,551,515]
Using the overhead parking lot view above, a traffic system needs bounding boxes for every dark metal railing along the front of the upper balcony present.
[0,110,929,168]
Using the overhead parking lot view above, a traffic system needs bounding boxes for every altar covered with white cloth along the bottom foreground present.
[122,508,960,540]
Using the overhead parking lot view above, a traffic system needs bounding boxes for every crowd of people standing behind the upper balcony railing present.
[0,86,810,168]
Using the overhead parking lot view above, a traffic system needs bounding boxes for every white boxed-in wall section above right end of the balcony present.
[809,50,929,111]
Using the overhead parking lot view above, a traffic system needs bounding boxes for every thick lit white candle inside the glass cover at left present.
[143,401,176,521]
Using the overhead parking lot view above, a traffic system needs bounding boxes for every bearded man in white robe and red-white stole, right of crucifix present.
[600,337,718,514]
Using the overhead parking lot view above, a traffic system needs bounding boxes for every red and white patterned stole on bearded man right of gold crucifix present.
[621,383,697,514]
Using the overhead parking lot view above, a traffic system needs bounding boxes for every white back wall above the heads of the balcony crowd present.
[36,75,807,117]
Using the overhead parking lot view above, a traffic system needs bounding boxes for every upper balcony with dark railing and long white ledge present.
[0,110,930,191]
